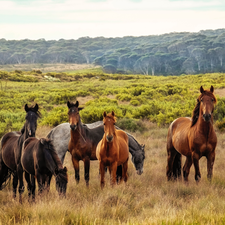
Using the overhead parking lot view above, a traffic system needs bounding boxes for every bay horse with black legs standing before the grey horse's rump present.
[67,101,102,186]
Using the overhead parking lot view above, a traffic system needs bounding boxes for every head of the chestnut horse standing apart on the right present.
[198,86,216,122]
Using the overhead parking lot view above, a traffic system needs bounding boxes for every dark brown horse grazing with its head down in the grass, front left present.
[21,137,68,200]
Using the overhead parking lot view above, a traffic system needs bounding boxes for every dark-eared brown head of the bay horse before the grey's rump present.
[67,101,83,130]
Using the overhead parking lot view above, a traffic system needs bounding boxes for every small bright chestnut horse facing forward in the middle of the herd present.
[96,111,129,188]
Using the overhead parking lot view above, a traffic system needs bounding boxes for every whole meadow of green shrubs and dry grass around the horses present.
[0,66,225,225]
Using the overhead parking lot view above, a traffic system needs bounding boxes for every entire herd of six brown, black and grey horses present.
[0,86,217,202]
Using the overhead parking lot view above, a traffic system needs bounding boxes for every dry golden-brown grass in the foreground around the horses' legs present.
[0,122,225,224]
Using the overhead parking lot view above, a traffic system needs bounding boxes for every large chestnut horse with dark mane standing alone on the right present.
[167,86,217,182]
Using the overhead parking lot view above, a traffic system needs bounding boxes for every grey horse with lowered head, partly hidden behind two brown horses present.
[46,121,145,176]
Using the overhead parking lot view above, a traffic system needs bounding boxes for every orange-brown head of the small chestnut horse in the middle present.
[103,111,116,142]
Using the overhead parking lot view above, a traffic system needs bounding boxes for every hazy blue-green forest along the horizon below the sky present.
[0,29,225,76]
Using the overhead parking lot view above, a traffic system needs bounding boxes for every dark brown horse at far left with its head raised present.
[0,104,41,202]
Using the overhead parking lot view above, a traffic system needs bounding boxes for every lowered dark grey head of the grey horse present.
[129,145,145,175]
